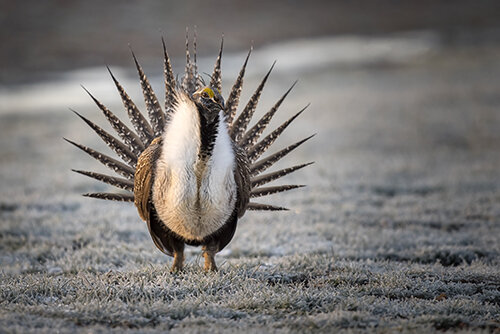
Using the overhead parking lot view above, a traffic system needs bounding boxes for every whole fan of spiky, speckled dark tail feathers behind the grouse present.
[65,36,312,211]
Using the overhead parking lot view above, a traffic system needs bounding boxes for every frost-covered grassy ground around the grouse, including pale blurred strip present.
[0,33,500,333]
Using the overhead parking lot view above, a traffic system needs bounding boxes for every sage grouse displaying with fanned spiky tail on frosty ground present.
[65,39,312,271]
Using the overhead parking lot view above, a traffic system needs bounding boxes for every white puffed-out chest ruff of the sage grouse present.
[153,95,236,240]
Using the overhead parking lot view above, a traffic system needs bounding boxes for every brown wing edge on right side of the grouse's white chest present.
[234,145,252,218]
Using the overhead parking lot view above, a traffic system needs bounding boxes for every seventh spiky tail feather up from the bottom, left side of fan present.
[132,52,165,138]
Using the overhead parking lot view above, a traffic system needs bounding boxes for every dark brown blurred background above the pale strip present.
[0,0,500,87]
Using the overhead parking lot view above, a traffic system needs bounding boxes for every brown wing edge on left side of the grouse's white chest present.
[134,137,161,222]
